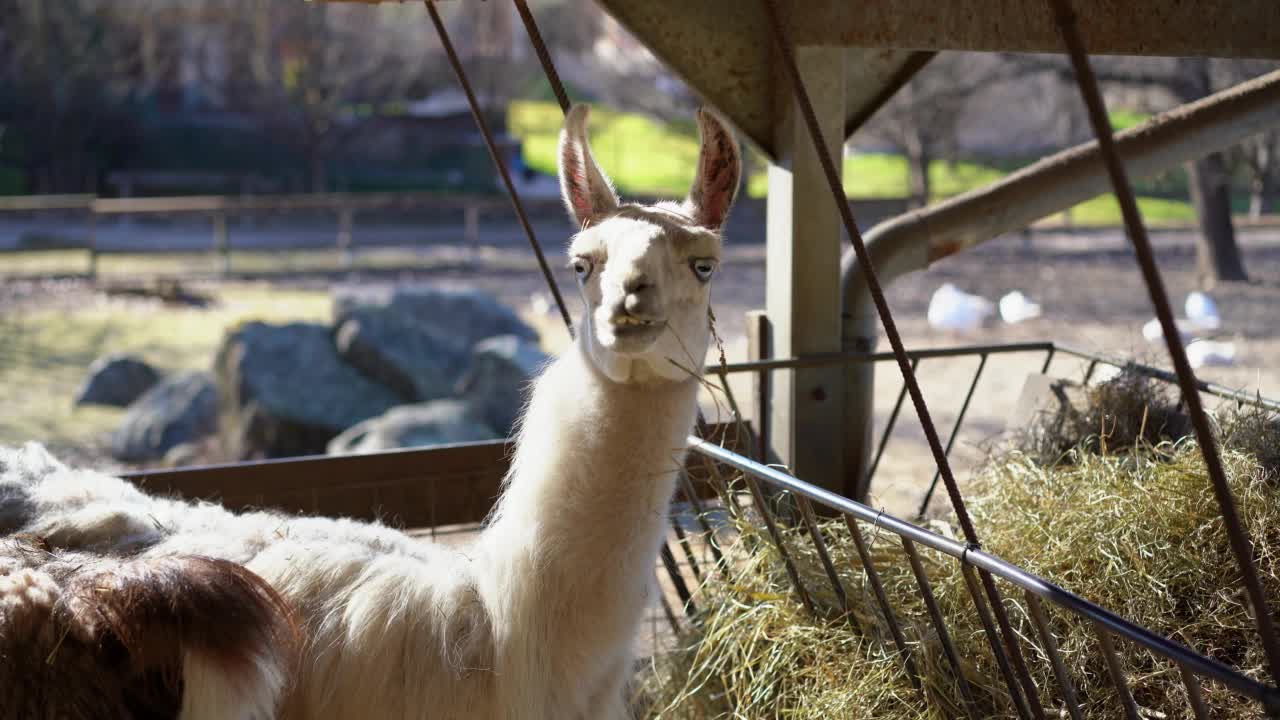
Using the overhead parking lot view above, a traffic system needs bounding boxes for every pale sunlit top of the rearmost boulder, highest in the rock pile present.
[333,284,538,348]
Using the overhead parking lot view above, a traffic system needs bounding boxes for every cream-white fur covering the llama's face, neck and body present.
[0,108,737,720]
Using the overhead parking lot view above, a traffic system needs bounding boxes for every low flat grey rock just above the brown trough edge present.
[329,400,499,455]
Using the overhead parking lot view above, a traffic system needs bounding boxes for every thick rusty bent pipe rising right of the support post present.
[841,70,1280,497]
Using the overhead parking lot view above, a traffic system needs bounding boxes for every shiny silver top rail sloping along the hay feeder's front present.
[687,436,1280,708]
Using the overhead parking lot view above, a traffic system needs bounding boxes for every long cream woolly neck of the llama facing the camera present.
[483,338,698,612]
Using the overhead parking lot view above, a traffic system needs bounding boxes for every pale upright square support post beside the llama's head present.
[765,47,847,493]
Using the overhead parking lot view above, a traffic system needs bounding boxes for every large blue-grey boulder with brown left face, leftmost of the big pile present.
[214,323,401,460]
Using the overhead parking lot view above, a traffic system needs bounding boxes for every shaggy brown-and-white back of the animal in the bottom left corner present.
[0,537,298,720]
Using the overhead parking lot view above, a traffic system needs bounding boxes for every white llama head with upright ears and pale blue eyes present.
[559,105,741,382]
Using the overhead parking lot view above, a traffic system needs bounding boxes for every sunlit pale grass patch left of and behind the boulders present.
[0,284,330,447]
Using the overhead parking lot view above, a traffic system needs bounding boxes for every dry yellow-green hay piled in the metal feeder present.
[637,377,1280,720]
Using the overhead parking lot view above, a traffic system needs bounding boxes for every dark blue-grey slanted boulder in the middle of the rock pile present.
[333,307,467,402]
